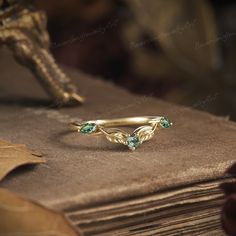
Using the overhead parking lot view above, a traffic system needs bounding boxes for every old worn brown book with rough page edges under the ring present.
[0,48,236,236]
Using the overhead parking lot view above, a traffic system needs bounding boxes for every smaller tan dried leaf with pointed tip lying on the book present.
[0,140,45,180]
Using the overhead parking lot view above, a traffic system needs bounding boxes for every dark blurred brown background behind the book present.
[2,0,236,120]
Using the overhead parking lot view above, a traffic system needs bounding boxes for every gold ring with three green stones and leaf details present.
[69,116,172,150]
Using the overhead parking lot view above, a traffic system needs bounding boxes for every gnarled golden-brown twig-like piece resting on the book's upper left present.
[0,0,84,105]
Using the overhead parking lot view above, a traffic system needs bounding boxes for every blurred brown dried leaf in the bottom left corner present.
[0,189,78,236]
